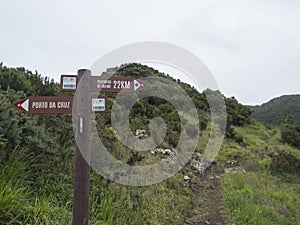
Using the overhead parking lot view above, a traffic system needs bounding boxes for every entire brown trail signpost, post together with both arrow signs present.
[13,69,146,225]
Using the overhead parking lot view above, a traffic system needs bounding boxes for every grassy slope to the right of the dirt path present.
[219,123,300,224]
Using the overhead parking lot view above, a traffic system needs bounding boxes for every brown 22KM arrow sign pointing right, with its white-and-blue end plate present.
[60,75,146,92]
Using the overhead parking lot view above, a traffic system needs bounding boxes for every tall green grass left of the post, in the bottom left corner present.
[0,149,71,225]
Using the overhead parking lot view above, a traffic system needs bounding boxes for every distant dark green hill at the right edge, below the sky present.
[252,95,300,126]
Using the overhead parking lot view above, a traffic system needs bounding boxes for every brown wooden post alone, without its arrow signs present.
[72,70,91,225]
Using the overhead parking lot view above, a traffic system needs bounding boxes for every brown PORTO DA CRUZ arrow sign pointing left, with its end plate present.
[13,96,107,114]
